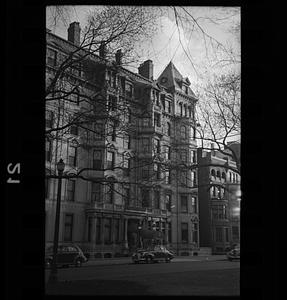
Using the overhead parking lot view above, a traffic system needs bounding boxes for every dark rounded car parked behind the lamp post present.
[45,244,88,268]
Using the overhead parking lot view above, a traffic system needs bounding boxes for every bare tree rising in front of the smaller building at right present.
[197,72,241,173]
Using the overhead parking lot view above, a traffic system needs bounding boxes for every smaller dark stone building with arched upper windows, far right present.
[197,144,240,254]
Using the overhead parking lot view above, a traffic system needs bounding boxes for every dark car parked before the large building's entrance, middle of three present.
[132,246,174,263]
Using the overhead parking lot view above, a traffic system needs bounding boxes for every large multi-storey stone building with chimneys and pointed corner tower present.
[45,22,199,258]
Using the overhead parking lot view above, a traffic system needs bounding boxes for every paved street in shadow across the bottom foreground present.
[46,259,240,296]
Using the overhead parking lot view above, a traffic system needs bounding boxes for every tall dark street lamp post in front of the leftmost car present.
[49,159,65,282]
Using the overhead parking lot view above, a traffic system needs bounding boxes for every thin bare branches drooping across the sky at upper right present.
[167,6,241,77]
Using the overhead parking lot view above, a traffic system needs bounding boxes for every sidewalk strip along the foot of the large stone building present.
[83,255,226,266]
